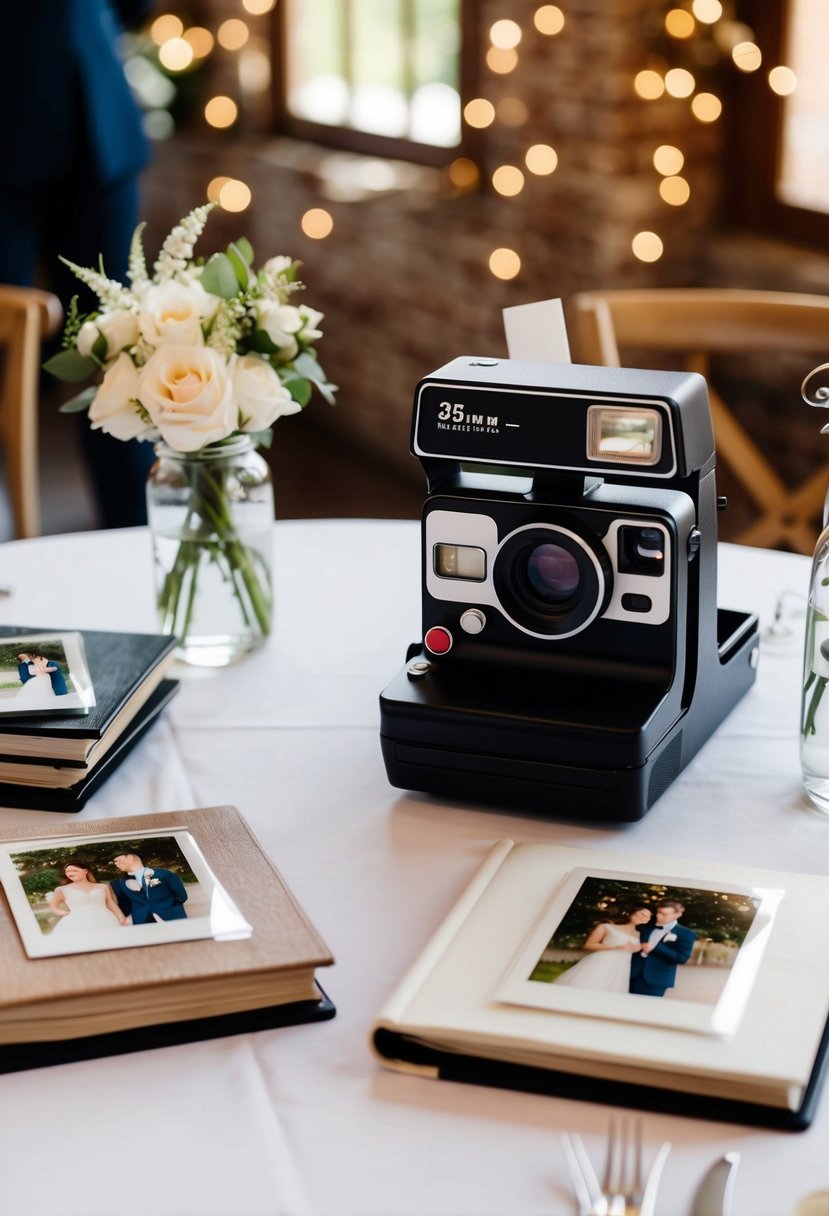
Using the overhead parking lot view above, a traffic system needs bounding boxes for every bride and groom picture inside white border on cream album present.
[528,877,757,1004]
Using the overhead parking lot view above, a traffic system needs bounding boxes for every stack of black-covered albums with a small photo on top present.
[0,626,179,811]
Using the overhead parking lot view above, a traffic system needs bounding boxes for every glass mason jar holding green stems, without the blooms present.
[147,435,273,668]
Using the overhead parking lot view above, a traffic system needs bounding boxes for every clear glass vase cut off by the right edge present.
[800,528,829,815]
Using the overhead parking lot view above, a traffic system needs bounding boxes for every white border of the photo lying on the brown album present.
[0,824,253,958]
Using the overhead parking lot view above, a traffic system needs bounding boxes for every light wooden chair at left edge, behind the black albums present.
[0,285,63,537]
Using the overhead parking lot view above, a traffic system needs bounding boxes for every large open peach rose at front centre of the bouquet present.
[137,345,237,452]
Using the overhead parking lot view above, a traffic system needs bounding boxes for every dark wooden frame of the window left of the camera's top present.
[271,0,481,168]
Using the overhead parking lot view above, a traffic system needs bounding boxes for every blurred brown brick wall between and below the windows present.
[138,0,829,503]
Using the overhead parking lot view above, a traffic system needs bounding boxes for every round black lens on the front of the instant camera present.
[492,518,613,638]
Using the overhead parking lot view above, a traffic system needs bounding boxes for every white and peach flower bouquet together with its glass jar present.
[45,204,335,663]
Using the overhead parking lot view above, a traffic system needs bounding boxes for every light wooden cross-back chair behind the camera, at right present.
[568,287,829,553]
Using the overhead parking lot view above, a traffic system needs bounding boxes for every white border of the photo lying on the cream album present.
[492,866,785,1036]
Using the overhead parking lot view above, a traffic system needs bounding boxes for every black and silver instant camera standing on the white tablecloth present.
[380,358,758,821]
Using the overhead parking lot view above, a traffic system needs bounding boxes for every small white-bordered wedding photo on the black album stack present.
[0,634,95,719]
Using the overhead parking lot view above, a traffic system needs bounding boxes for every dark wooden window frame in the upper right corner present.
[724,0,829,249]
